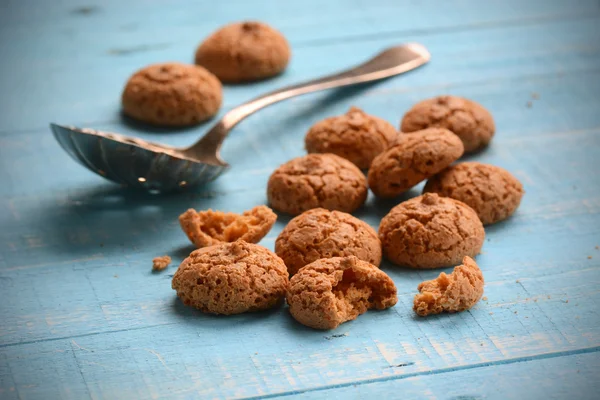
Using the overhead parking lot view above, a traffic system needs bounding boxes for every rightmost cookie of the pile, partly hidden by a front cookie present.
[423,162,524,225]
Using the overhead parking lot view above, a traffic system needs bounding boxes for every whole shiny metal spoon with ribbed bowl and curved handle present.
[50,43,430,192]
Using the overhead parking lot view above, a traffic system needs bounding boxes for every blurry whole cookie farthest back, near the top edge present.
[196,21,291,83]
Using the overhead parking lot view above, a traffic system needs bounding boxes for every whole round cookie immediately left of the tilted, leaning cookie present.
[267,154,367,215]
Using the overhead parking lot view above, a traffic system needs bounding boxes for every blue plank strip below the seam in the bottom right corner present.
[282,353,600,400]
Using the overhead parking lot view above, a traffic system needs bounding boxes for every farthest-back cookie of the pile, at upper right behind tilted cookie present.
[400,96,496,153]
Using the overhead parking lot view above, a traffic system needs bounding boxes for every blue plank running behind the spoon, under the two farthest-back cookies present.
[0,11,600,132]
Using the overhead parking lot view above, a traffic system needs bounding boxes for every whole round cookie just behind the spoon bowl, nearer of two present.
[121,63,223,126]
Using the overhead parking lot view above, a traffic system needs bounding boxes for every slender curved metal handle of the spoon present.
[185,43,431,158]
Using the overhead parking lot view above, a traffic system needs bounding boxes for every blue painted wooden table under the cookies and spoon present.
[0,0,600,399]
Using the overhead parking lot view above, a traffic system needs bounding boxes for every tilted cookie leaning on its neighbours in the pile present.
[369,128,464,197]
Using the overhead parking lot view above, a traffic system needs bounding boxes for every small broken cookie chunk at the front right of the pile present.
[413,257,484,317]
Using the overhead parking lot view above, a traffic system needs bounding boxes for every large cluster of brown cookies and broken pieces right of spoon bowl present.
[166,95,524,329]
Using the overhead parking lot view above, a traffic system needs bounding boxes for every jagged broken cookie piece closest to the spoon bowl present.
[179,206,277,248]
